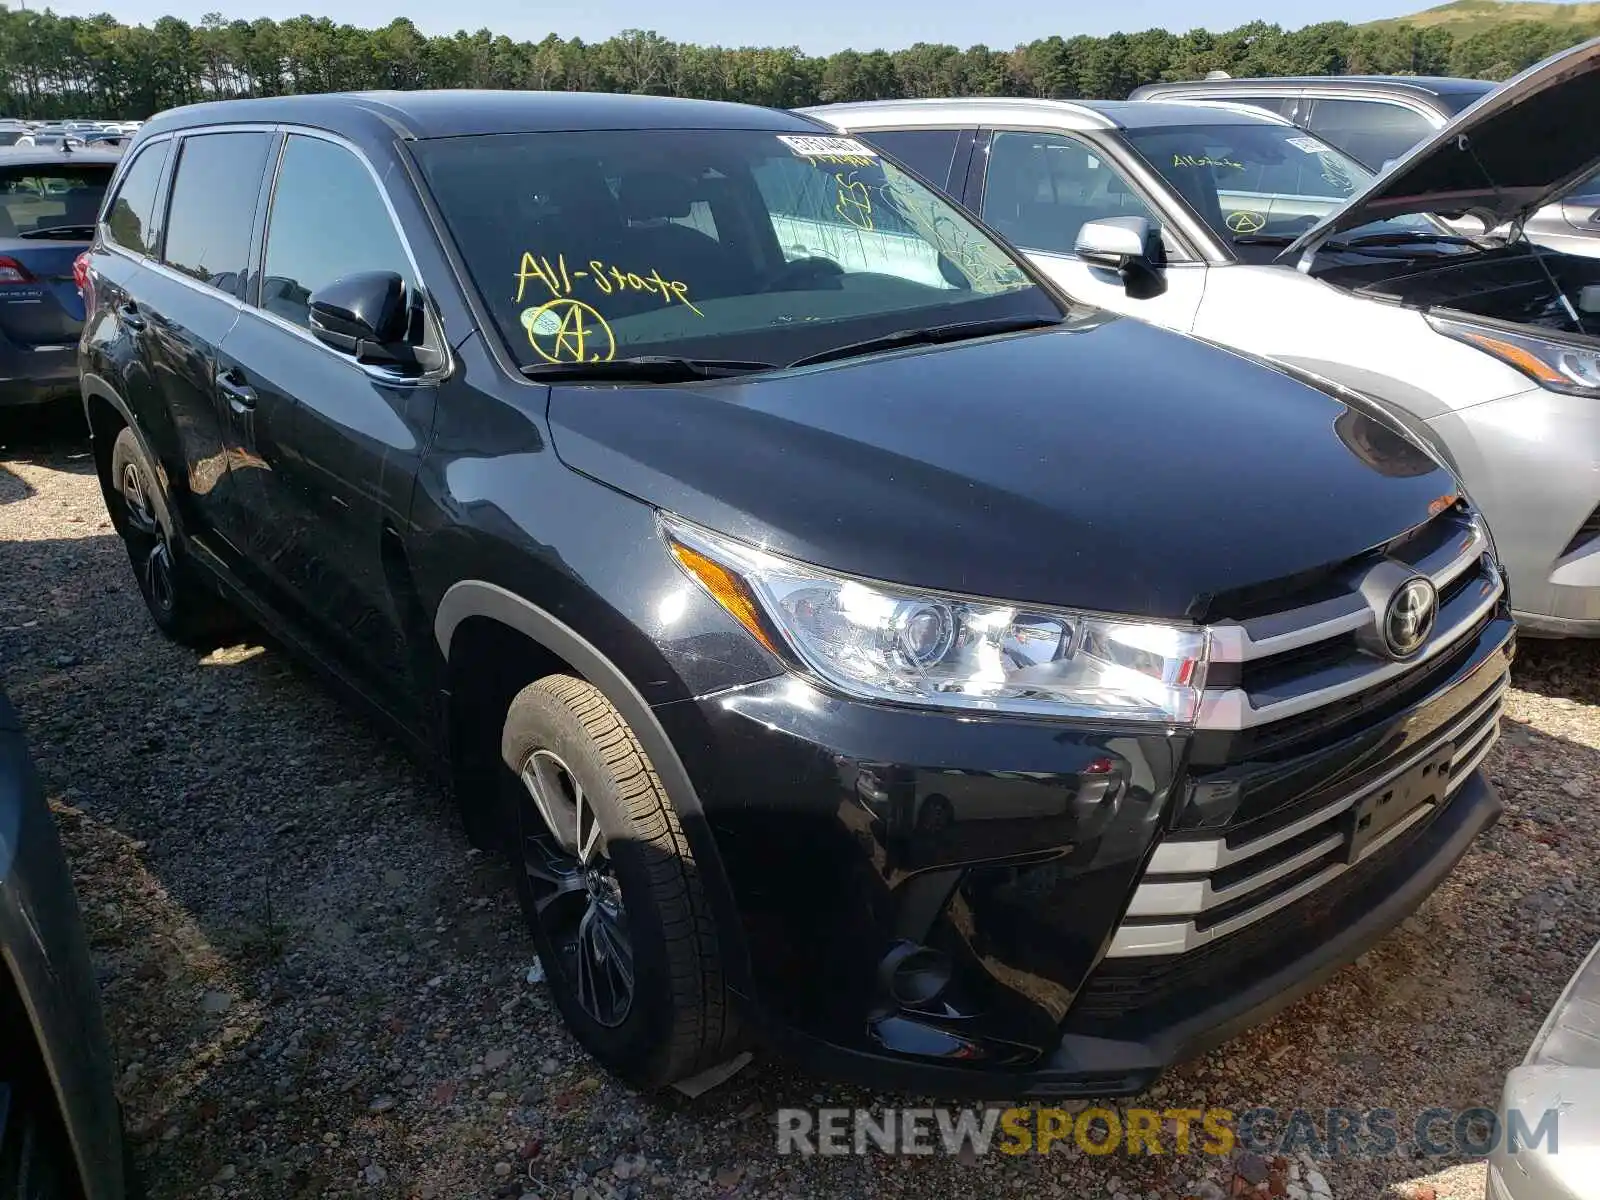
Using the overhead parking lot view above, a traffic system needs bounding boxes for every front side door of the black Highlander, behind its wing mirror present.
[218,131,443,704]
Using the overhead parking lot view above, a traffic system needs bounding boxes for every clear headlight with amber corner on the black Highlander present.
[661,514,1206,723]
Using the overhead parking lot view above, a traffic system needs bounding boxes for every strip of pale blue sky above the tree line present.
[28,0,1472,54]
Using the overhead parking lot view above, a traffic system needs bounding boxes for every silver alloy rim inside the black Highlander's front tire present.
[518,750,634,1029]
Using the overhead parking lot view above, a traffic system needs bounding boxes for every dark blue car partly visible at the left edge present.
[0,146,122,406]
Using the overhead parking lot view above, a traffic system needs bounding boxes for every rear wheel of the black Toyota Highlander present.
[110,429,234,645]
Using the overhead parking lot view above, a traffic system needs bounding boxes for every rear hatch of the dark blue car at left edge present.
[0,155,115,360]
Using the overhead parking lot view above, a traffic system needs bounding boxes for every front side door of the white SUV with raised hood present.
[966,130,1206,331]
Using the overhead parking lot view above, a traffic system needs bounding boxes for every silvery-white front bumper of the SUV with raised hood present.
[1429,387,1600,637]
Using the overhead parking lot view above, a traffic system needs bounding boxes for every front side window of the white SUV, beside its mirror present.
[982,130,1171,254]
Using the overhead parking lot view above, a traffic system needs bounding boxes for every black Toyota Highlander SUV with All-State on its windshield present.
[82,91,1512,1096]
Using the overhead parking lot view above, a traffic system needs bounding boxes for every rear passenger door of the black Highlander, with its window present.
[140,130,275,562]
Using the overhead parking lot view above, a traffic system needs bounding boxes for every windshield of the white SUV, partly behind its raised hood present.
[1123,123,1450,261]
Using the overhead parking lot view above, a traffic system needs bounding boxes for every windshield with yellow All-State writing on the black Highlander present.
[414,130,1064,366]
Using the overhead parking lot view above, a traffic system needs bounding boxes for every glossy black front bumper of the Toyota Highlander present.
[658,613,1510,1098]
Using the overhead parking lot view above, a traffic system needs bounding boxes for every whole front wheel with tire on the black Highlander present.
[501,675,738,1088]
